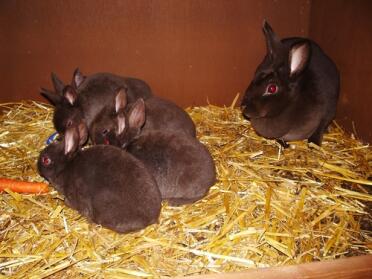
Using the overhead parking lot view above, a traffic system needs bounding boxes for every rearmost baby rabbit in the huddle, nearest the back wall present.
[41,69,152,137]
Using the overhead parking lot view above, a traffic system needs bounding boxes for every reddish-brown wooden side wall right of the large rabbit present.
[310,0,372,143]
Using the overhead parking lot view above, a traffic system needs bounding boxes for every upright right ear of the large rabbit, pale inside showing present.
[289,42,310,77]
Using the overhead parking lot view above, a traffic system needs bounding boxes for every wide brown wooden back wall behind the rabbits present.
[0,0,310,106]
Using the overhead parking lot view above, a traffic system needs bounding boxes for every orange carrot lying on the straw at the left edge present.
[0,178,48,194]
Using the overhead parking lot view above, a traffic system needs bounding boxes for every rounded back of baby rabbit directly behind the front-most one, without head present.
[128,131,216,205]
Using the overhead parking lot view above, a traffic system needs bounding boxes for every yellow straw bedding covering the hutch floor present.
[0,101,372,278]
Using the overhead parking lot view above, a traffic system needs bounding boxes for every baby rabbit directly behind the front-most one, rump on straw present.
[91,96,216,205]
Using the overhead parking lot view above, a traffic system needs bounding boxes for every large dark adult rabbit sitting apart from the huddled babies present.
[241,22,340,145]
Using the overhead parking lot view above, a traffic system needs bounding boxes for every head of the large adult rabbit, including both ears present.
[241,21,311,119]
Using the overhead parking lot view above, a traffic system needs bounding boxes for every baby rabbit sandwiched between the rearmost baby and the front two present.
[89,88,196,145]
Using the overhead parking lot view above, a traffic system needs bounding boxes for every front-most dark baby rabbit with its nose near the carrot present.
[37,124,161,233]
